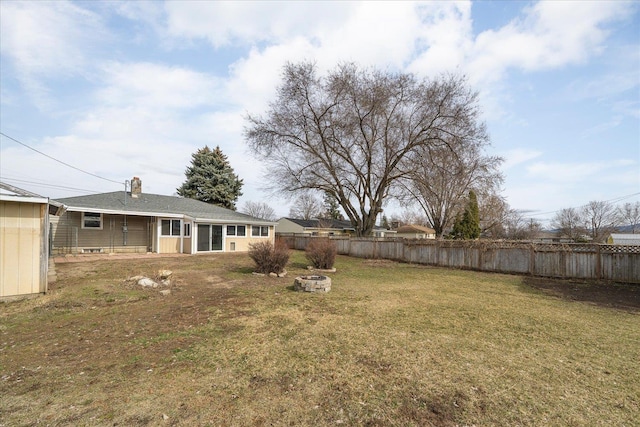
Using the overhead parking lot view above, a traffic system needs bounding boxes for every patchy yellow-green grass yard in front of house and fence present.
[0,251,640,426]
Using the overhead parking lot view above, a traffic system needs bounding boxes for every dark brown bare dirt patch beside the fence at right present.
[523,277,640,312]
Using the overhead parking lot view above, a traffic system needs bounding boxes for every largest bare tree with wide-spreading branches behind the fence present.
[245,63,485,236]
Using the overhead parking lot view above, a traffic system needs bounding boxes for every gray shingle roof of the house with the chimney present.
[57,191,274,224]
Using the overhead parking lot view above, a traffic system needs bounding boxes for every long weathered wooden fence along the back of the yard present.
[278,234,640,284]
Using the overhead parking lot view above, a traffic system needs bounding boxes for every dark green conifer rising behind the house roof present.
[177,146,243,210]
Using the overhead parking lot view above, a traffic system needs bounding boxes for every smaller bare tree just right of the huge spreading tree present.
[399,130,503,236]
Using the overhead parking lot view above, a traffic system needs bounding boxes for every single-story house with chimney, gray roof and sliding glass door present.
[52,177,275,254]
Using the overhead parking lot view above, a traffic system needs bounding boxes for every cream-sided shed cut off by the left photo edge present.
[0,182,64,298]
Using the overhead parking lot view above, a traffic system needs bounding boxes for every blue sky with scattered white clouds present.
[0,0,640,224]
